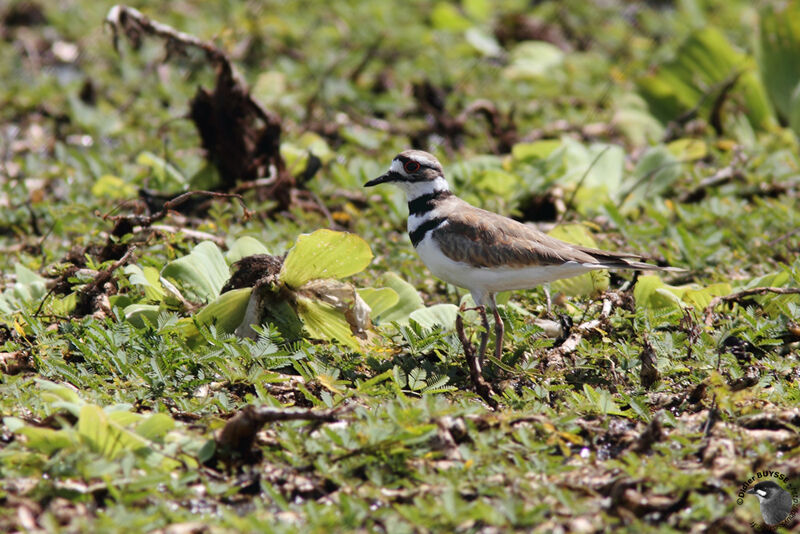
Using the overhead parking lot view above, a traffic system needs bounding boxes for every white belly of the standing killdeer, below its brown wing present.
[417,234,596,294]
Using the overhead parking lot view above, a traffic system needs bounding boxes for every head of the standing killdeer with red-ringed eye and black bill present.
[364,150,449,200]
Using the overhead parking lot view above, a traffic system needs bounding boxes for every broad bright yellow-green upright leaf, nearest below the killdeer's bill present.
[280,230,372,289]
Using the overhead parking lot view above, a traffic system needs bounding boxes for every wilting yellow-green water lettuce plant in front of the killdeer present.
[136,230,398,349]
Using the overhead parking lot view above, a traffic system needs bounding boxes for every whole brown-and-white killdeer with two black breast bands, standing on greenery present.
[364,150,679,400]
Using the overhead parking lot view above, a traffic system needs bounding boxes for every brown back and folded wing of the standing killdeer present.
[433,197,658,269]
